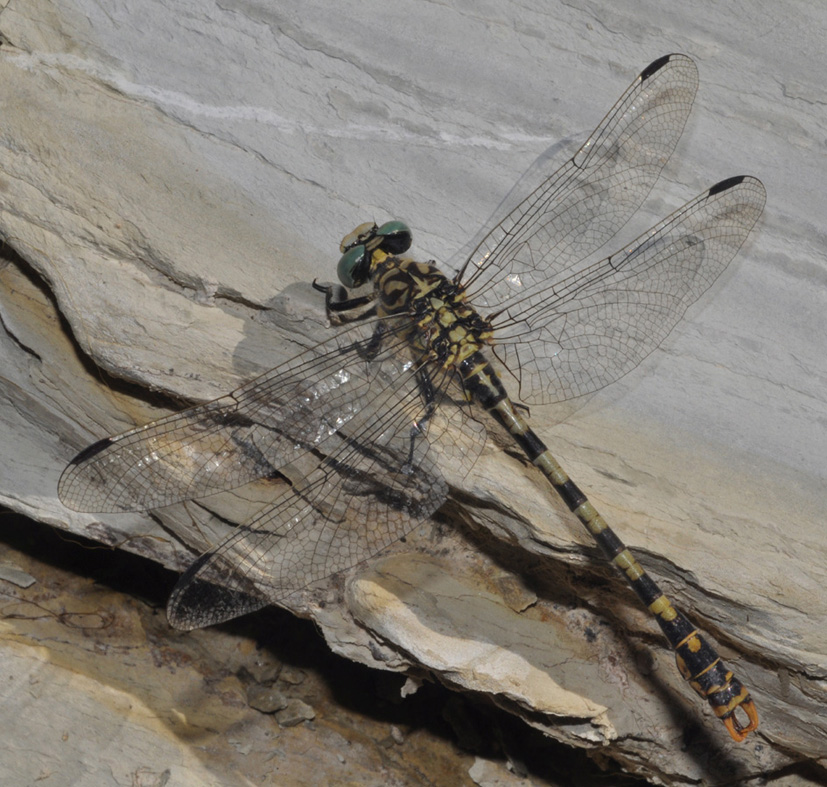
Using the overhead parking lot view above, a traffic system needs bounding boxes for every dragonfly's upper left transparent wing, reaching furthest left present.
[58,321,418,512]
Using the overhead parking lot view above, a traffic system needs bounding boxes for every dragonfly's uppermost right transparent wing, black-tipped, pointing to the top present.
[459,54,698,316]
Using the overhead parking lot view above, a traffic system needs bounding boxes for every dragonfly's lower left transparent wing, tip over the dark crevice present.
[168,358,447,628]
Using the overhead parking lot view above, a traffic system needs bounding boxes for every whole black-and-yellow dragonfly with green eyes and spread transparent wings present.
[58,54,766,741]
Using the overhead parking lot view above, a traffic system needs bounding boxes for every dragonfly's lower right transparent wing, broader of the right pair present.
[494,176,766,404]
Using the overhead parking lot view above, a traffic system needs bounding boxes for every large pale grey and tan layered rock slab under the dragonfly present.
[0,0,827,784]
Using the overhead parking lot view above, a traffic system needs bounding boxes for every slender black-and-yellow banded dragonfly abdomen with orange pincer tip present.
[489,398,758,743]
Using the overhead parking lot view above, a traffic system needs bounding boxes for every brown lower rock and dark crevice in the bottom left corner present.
[0,516,512,787]
